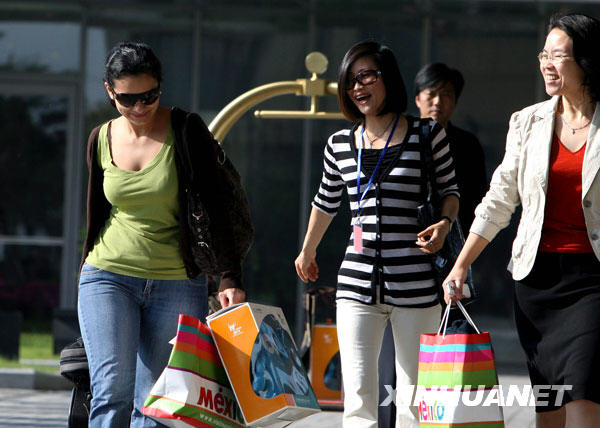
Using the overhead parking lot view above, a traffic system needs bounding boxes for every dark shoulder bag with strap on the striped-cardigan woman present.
[417,124,476,304]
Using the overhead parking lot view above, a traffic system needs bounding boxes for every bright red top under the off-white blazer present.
[540,135,594,253]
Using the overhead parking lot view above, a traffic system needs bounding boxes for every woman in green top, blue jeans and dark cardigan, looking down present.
[78,42,248,427]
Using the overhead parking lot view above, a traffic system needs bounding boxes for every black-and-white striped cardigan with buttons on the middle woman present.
[312,116,459,307]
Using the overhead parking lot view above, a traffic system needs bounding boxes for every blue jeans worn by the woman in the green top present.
[77,264,208,428]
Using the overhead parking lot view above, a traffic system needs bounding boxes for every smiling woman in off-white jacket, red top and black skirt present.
[444,14,600,428]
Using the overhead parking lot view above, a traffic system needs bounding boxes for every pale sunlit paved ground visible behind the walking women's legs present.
[0,375,534,428]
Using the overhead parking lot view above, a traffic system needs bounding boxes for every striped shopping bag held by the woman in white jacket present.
[415,302,504,428]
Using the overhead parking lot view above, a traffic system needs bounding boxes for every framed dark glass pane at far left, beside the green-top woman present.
[0,95,68,237]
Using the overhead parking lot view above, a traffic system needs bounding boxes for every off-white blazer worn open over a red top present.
[470,96,600,281]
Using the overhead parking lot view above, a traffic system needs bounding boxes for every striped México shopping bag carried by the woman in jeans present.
[142,315,244,428]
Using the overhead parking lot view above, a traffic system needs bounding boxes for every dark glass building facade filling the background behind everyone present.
[0,0,600,342]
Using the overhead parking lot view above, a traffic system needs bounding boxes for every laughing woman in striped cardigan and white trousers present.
[295,41,458,427]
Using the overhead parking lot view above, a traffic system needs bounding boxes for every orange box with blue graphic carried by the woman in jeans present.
[208,303,320,426]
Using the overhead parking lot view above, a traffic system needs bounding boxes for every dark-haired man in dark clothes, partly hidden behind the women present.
[415,62,488,238]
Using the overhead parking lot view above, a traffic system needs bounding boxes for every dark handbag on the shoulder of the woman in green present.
[173,109,254,275]
